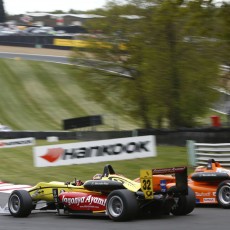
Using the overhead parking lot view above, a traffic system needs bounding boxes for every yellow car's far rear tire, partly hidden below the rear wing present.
[169,187,196,216]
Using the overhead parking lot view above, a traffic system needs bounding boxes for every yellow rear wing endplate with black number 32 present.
[140,169,153,199]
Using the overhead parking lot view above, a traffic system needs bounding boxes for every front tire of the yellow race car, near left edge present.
[8,190,33,217]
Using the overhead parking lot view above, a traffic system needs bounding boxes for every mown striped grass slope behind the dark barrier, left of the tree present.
[0,59,139,131]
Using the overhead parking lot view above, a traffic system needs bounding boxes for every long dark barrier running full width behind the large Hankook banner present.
[0,128,230,146]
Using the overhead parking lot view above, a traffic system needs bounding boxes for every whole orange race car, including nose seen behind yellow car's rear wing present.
[136,159,230,209]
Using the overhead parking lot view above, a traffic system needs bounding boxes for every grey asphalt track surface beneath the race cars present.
[0,193,230,230]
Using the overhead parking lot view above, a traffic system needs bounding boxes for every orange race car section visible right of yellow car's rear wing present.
[188,159,230,209]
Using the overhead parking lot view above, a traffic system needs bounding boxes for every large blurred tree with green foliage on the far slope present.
[73,0,224,128]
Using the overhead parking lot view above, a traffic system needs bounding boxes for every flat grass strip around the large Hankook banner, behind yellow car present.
[0,141,188,185]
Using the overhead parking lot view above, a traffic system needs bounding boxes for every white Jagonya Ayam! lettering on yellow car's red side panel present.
[62,195,106,206]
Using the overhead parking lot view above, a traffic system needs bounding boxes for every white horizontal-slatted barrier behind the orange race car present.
[187,140,230,167]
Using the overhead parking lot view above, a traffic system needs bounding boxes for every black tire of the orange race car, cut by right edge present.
[216,180,230,209]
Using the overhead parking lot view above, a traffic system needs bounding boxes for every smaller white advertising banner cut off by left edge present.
[0,137,35,148]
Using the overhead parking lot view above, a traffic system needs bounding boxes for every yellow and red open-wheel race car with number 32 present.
[8,165,195,221]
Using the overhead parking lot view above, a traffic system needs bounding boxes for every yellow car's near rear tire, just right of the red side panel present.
[106,189,138,221]
